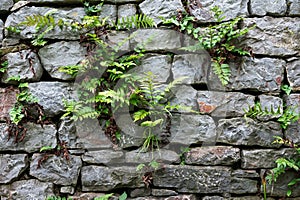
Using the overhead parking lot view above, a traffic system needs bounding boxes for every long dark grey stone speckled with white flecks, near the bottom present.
[153,166,257,194]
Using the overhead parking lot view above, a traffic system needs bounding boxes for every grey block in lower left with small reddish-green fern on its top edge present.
[29,154,82,186]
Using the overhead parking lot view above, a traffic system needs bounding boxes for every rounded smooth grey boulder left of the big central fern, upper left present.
[39,41,86,80]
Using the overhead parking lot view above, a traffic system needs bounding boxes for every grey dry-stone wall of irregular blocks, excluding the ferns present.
[0,0,300,200]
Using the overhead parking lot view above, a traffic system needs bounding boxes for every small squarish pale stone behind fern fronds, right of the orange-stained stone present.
[257,94,283,121]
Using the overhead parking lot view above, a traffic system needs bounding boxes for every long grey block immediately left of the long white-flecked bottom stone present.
[81,166,144,191]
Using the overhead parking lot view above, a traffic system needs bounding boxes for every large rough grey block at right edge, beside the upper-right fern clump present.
[243,16,300,56]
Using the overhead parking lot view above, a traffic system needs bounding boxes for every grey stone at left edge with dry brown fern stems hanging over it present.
[1,50,43,84]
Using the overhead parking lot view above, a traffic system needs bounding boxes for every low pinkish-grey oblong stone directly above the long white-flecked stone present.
[185,146,240,165]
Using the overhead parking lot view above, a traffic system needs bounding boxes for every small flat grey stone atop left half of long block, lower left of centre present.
[82,149,124,165]
